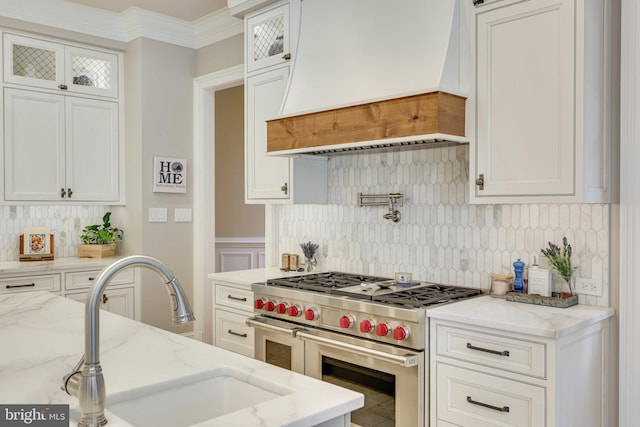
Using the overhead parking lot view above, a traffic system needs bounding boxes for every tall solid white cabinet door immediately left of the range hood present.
[245,67,291,203]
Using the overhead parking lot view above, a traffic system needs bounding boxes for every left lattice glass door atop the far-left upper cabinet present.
[4,33,64,89]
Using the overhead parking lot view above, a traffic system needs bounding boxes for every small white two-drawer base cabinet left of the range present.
[213,280,255,357]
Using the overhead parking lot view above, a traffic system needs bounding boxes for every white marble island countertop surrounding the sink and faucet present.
[0,291,364,427]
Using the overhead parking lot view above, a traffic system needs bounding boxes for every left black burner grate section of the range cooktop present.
[267,272,390,293]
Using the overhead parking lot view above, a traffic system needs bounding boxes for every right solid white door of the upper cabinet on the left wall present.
[66,97,119,201]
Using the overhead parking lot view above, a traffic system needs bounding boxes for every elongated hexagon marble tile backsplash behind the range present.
[276,147,610,305]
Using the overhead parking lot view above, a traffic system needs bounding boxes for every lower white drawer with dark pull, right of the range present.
[434,363,546,427]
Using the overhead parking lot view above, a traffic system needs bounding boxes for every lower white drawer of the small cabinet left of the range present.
[214,310,254,357]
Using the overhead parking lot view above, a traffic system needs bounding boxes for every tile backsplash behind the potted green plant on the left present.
[0,206,109,261]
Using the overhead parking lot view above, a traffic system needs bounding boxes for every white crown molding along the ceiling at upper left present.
[0,0,244,49]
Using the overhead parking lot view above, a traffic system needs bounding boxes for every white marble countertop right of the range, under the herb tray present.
[427,296,614,338]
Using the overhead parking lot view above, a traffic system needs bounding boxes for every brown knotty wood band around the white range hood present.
[267,92,466,152]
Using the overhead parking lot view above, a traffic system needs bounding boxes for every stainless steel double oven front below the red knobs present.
[247,316,428,427]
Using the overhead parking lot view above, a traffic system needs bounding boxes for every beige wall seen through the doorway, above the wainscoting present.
[215,86,264,238]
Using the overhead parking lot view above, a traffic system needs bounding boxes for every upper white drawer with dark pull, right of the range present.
[436,324,546,378]
